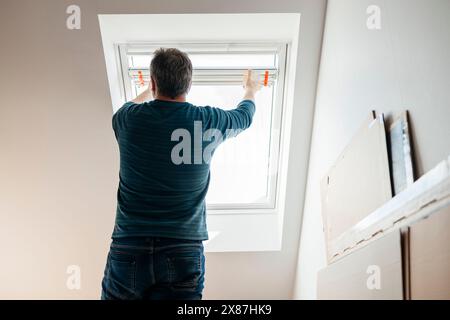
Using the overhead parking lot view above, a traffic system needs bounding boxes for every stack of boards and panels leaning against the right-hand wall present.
[318,113,450,299]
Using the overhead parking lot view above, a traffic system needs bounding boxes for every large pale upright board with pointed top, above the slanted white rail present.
[321,112,392,259]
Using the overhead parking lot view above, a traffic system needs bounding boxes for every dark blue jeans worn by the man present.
[101,237,205,300]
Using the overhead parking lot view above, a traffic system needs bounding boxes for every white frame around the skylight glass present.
[115,41,289,214]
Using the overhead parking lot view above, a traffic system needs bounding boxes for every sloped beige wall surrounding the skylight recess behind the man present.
[0,0,325,299]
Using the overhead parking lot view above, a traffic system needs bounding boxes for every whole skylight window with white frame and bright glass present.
[117,43,286,212]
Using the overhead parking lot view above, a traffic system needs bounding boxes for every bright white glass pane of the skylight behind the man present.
[188,85,273,204]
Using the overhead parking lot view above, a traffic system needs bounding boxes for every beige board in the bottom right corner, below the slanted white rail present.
[409,206,450,300]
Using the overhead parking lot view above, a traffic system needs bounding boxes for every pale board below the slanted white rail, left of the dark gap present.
[317,230,403,300]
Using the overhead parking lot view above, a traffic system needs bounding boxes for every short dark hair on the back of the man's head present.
[150,48,192,99]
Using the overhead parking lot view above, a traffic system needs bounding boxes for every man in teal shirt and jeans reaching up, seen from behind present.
[102,48,260,299]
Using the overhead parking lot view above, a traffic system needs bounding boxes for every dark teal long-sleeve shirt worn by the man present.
[112,100,255,240]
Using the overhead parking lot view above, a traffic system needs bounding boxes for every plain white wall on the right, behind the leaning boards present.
[294,0,450,299]
